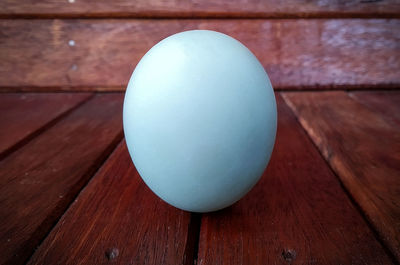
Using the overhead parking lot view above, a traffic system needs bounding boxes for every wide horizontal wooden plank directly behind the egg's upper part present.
[0,19,400,90]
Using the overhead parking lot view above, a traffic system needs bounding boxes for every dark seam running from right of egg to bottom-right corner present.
[280,91,400,265]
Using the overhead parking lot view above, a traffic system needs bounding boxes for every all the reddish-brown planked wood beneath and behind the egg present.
[0,0,400,265]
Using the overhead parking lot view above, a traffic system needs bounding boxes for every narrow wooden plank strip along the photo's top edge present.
[0,0,400,18]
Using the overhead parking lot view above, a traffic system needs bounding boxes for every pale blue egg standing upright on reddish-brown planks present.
[123,30,277,212]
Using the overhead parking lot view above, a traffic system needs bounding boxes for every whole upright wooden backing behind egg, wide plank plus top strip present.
[0,0,400,91]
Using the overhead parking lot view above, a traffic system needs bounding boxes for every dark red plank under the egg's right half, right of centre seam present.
[198,95,391,265]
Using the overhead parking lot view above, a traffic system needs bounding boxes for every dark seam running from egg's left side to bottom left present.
[24,135,123,264]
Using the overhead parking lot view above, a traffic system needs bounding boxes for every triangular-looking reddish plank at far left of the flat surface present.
[0,93,90,159]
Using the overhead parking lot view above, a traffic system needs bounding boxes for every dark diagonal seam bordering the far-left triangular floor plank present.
[0,93,94,161]
